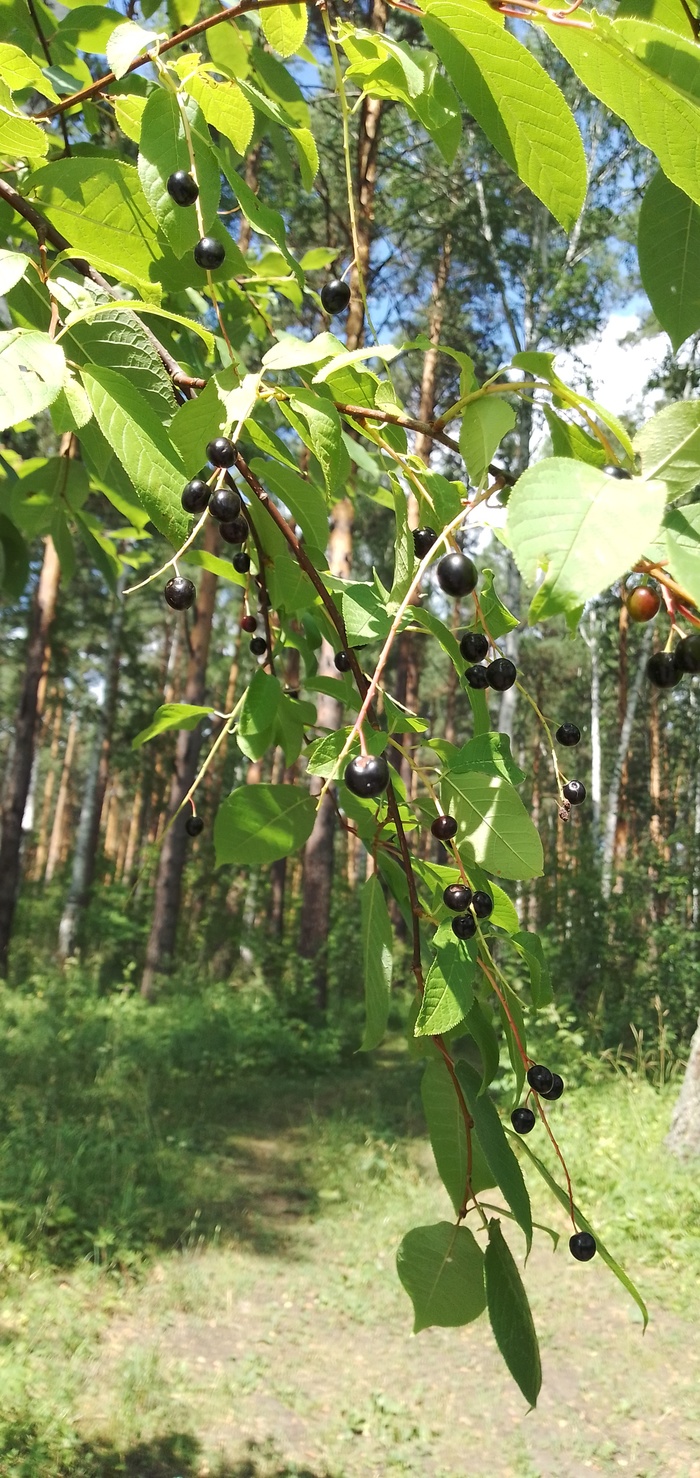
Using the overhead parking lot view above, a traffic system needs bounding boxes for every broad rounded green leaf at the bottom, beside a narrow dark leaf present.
[396,1221,486,1335]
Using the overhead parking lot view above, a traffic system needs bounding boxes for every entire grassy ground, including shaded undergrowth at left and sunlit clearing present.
[0,998,700,1478]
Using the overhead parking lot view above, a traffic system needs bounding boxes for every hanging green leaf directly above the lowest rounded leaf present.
[421,1060,496,1212]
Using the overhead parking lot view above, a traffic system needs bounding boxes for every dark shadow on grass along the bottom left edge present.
[0,1423,334,1478]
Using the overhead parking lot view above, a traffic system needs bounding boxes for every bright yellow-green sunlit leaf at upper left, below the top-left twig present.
[30,155,161,282]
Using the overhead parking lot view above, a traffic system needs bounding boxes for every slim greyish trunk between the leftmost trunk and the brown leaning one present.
[59,575,126,959]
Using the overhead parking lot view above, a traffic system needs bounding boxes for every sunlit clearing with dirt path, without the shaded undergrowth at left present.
[0,993,700,1478]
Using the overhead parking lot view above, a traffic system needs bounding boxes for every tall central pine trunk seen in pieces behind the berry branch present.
[298,0,387,1011]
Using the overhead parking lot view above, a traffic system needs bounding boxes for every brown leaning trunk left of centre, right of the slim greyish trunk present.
[140,519,219,998]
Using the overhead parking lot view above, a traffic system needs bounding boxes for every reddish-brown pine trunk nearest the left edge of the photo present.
[0,532,61,977]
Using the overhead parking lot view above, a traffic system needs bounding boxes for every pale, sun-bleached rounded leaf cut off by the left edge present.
[0,328,65,432]
